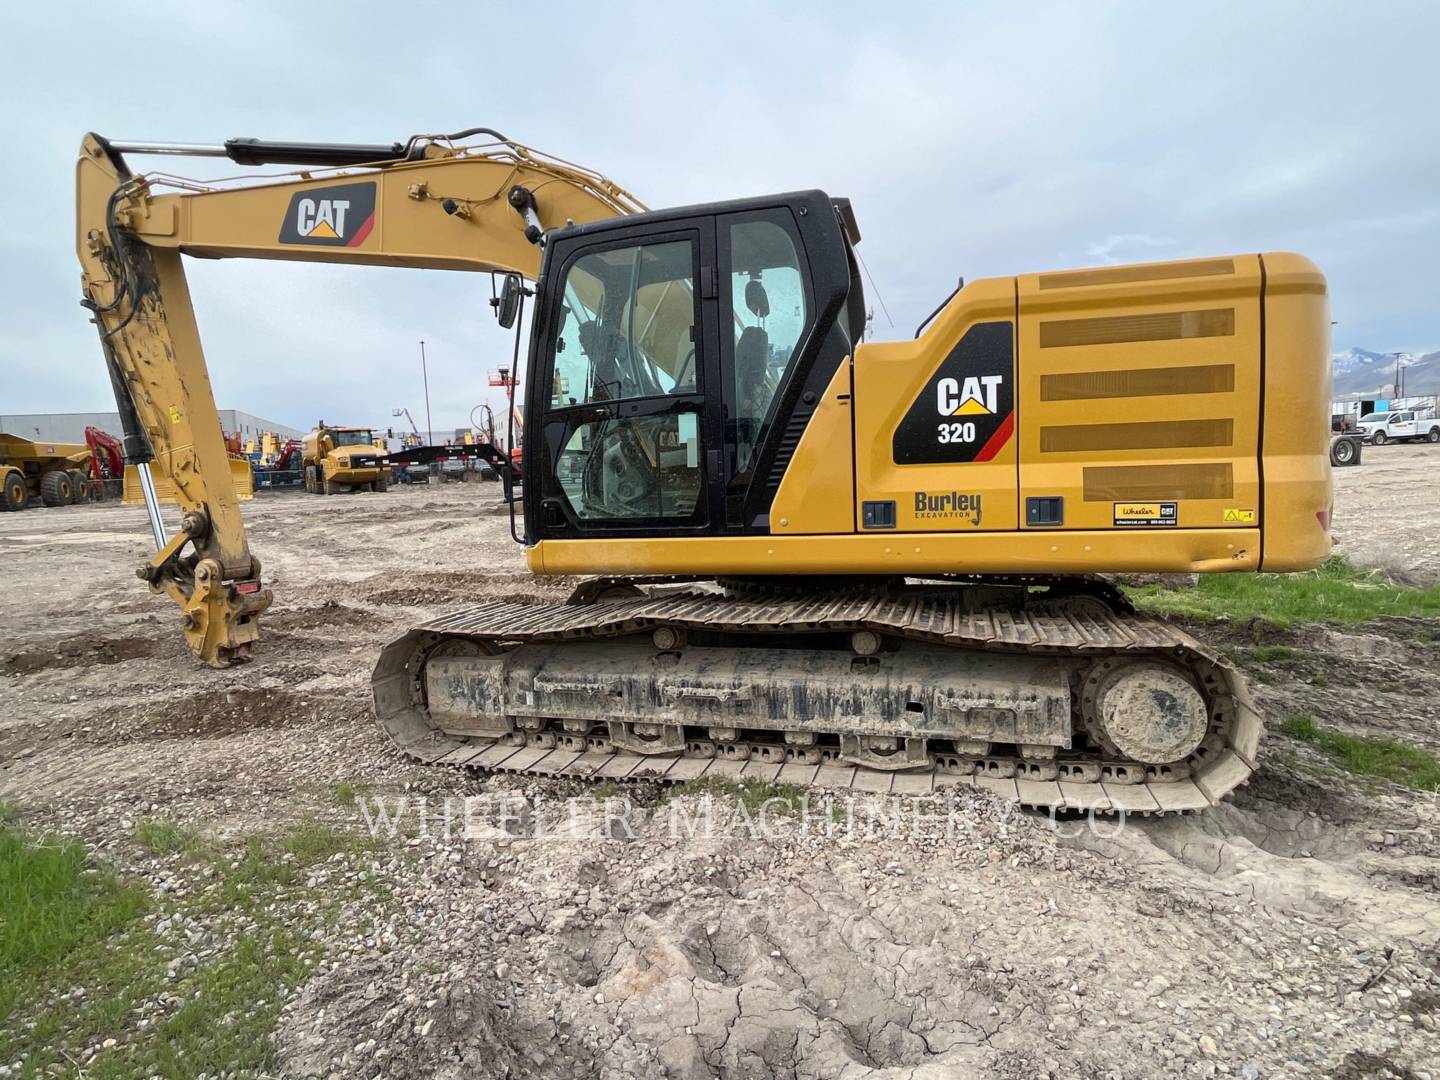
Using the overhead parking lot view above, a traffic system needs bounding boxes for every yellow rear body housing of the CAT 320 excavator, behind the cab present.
[528,253,1331,576]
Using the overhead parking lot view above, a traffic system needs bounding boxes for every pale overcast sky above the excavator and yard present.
[0,0,1440,432]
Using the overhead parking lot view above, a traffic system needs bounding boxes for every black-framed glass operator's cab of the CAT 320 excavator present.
[524,192,864,544]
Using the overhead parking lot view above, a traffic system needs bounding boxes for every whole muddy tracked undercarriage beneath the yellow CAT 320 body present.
[373,577,1263,814]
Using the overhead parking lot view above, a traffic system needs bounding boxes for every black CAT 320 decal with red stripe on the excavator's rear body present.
[893,323,1015,465]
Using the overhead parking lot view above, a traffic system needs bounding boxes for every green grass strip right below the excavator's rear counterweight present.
[1126,556,1440,630]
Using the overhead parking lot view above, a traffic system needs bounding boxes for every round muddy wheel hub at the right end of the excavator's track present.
[1083,661,1210,765]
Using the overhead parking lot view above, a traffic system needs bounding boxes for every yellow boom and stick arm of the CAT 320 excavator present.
[75,128,644,667]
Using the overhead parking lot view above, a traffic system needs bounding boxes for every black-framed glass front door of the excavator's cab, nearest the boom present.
[527,217,723,539]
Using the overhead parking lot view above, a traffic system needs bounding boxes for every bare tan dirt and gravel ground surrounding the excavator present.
[0,446,1440,1080]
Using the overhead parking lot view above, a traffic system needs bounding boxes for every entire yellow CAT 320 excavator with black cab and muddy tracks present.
[76,128,1331,814]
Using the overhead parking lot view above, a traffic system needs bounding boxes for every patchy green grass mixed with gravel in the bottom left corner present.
[0,821,382,1080]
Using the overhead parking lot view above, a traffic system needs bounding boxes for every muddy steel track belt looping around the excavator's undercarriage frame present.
[372,586,1263,814]
